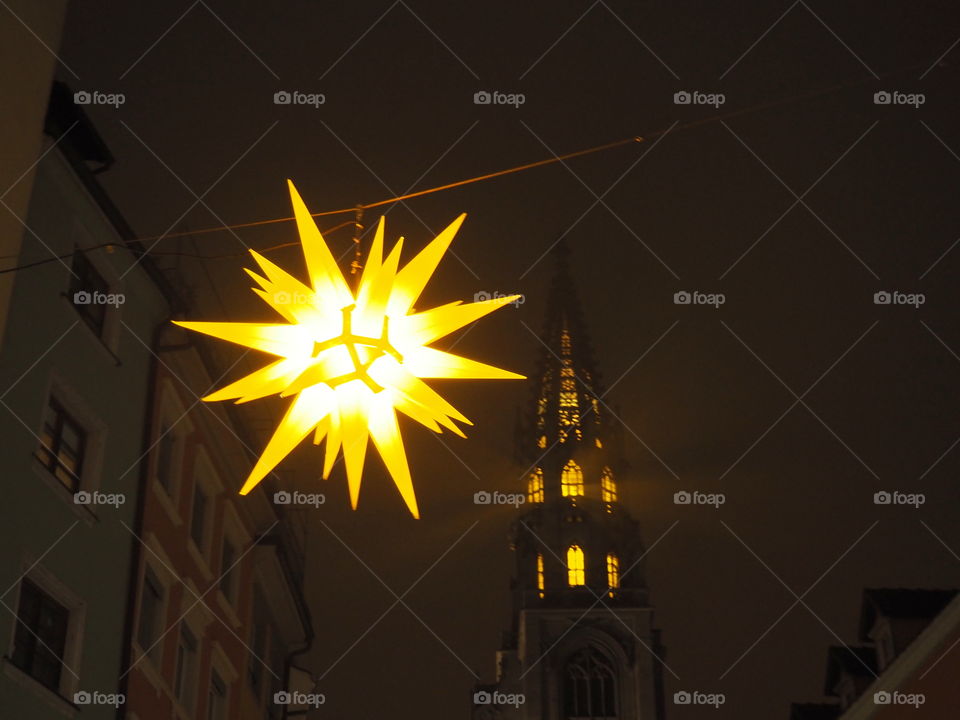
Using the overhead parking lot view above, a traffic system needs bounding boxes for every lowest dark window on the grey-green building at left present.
[11,578,70,692]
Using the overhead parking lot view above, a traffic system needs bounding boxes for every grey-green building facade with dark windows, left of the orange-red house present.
[0,83,170,720]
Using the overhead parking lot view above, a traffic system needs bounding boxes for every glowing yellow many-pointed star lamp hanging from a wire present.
[176,181,523,517]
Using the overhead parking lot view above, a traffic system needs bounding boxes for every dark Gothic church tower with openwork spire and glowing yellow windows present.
[473,247,664,720]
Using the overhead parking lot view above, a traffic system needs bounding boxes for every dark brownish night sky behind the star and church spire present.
[61,0,960,720]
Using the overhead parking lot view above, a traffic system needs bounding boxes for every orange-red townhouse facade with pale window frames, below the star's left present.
[124,325,317,720]
